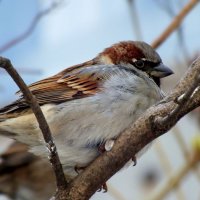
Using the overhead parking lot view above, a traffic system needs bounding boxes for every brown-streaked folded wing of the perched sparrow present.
[0,63,120,115]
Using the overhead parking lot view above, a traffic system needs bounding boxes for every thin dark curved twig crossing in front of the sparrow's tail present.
[0,57,67,190]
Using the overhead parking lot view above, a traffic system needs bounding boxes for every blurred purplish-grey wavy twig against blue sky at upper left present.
[0,1,61,54]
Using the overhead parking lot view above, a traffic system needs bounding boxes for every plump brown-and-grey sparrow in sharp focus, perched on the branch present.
[0,41,173,178]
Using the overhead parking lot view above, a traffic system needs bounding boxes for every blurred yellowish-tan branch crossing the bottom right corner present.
[148,151,200,200]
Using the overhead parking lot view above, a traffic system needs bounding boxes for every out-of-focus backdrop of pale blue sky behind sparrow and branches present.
[0,0,200,200]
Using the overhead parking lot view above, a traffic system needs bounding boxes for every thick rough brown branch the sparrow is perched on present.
[56,58,200,200]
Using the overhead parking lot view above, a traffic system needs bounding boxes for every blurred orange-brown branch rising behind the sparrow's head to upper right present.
[152,0,199,48]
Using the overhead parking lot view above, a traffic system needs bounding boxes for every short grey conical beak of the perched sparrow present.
[151,63,174,78]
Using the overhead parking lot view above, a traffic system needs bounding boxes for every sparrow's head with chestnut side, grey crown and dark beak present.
[97,41,173,85]
